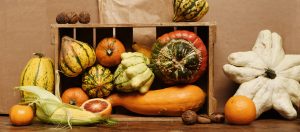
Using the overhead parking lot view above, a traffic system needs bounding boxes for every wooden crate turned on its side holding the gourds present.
[51,22,217,121]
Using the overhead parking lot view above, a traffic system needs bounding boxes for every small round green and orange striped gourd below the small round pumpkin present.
[82,64,113,98]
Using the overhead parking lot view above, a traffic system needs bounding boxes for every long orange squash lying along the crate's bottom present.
[107,85,206,116]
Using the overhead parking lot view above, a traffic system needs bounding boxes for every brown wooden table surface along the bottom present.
[0,115,300,132]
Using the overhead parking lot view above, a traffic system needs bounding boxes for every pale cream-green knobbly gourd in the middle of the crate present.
[114,52,154,93]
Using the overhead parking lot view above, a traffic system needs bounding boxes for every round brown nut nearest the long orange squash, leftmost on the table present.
[181,110,198,125]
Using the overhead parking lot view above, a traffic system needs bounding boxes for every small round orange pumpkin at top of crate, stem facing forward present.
[96,37,125,67]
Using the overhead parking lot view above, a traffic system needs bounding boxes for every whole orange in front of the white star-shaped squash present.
[224,95,256,125]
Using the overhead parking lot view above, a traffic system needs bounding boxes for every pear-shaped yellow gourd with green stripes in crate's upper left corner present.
[60,36,96,77]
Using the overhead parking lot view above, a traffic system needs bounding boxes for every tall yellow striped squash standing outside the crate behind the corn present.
[20,53,54,96]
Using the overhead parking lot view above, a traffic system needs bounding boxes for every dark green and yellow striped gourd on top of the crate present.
[173,0,209,22]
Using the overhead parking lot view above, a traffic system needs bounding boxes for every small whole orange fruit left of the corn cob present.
[9,105,34,126]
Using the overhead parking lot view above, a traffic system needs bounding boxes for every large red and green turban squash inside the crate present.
[151,30,207,84]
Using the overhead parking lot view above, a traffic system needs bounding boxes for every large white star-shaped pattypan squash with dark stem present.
[223,30,300,119]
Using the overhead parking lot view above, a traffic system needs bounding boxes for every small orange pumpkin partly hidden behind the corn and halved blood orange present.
[61,87,89,106]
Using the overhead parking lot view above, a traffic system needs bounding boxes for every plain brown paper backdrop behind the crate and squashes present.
[0,0,300,114]
